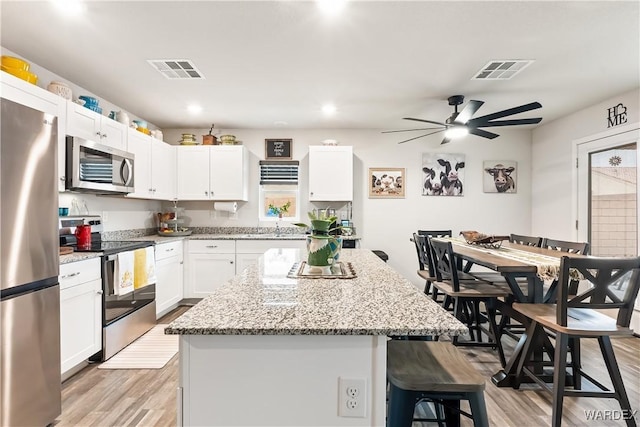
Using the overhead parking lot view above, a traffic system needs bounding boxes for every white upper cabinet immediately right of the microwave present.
[126,129,176,200]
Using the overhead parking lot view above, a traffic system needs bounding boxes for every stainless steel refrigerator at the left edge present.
[0,98,62,426]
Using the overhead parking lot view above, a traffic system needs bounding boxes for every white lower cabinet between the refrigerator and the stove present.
[59,258,102,374]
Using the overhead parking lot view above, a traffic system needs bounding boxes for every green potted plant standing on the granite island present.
[294,210,342,273]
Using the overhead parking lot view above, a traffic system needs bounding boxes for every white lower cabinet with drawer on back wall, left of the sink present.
[185,240,236,298]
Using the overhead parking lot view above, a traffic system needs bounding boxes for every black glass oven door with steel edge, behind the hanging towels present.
[102,254,156,326]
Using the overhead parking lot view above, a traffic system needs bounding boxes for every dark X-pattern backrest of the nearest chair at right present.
[556,256,640,327]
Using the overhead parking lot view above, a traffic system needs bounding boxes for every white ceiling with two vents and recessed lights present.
[0,0,640,129]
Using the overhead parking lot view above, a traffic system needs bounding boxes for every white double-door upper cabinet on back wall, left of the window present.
[176,145,249,200]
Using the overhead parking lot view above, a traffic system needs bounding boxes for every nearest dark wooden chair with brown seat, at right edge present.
[513,256,640,427]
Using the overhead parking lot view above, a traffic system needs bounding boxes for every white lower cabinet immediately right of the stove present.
[156,240,184,319]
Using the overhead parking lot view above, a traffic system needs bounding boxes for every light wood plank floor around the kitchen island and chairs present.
[54,307,640,427]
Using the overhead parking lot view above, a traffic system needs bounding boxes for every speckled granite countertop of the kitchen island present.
[165,249,467,335]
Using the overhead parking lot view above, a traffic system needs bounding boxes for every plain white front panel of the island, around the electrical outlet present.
[178,335,387,427]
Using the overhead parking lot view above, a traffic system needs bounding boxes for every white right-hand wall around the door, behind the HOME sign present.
[531,89,640,240]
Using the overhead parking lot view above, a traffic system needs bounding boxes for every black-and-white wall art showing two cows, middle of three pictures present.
[422,153,465,196]
